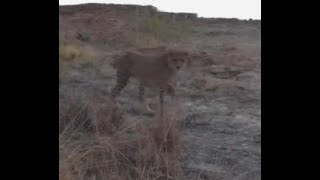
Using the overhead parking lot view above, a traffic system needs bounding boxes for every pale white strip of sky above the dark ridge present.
[59,0,261,20]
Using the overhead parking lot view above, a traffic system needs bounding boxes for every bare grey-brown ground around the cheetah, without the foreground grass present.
[59,4,261,180]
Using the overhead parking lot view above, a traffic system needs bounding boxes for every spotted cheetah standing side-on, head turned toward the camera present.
[110,49,189,114]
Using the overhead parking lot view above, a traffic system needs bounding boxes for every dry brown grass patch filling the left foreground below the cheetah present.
[59,97,182,180]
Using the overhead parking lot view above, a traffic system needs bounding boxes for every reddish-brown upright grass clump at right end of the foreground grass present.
[123,115,182,179]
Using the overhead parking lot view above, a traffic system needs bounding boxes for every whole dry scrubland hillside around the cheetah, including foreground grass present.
[59,4,261,180]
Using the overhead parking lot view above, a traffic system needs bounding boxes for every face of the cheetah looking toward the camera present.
[168,51,189,72]
